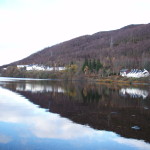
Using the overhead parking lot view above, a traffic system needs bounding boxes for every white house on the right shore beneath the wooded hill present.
[120,69,150,78]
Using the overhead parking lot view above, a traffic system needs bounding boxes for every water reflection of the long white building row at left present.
[16,83,64,93]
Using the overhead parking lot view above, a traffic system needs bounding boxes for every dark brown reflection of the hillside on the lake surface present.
[2,81,150,142]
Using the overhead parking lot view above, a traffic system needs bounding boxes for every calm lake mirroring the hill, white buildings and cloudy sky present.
[0,77,150,150]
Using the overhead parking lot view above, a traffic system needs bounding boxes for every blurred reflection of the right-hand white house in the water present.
[119,88,148,99]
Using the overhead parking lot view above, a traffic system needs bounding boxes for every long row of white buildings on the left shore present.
[17,65,65,71]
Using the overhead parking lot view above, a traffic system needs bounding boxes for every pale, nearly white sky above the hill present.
[0,0,150,65]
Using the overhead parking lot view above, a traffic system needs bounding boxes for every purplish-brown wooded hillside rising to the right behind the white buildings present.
[1,24,150,70]
